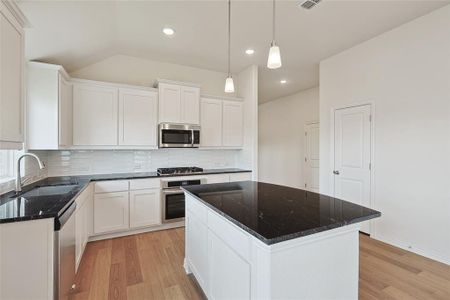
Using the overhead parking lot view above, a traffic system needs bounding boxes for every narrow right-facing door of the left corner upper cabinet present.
[58,75,72,147]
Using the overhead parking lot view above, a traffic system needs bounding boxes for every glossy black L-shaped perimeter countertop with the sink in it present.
[0,168,251,229]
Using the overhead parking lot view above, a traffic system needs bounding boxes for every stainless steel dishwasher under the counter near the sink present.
[53,202,76,300]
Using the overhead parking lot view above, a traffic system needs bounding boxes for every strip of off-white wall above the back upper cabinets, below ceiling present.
[70,55,236,96]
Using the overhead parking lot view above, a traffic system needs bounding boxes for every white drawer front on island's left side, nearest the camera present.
[208,210,250,261]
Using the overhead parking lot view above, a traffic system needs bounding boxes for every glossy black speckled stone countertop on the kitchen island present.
[183,181,381,245]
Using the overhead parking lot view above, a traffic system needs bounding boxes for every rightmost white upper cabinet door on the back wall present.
[222,101,243,147]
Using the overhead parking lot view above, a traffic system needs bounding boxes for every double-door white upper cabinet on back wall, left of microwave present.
[73,80,158,148]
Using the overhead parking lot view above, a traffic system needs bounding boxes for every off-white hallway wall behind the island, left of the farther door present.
[259,87,319,188]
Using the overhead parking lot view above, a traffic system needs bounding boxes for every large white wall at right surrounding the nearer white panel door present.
[320,6,450,263]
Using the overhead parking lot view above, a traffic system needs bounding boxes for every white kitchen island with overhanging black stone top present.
[184,181,381,299]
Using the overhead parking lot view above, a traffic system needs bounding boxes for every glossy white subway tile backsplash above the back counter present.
[46,149,239,176]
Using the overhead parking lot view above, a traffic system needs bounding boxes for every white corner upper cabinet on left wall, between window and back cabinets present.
[27,62,72,150]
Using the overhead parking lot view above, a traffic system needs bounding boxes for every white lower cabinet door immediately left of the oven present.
[130,189,161,228]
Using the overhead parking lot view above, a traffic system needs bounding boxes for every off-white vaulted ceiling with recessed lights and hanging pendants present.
[18,0,450,103]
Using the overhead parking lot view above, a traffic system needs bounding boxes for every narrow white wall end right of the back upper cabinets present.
[235,65,258,180]
